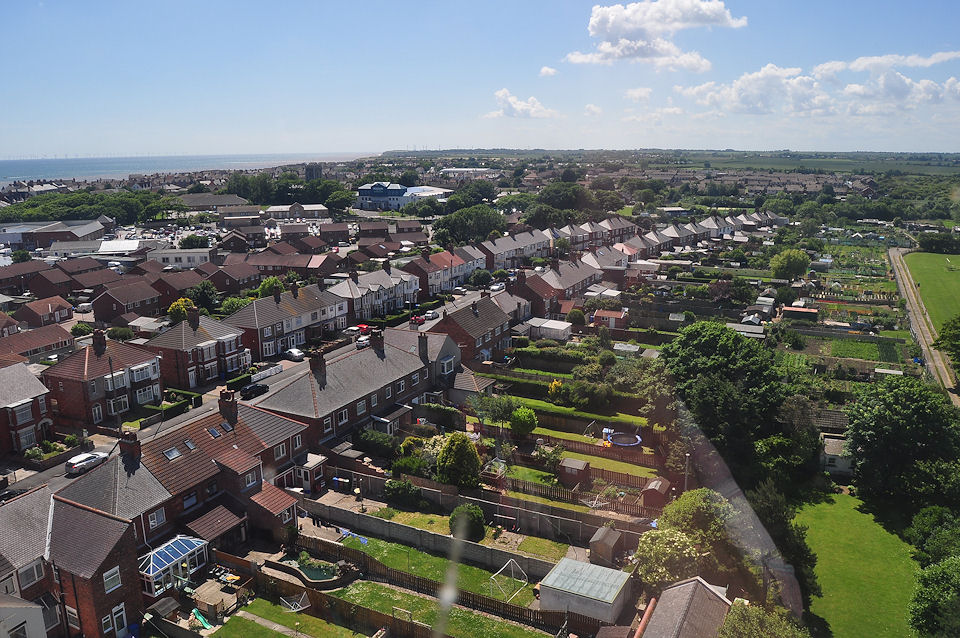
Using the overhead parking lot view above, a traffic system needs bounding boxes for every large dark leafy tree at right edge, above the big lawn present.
[847,377,960,504]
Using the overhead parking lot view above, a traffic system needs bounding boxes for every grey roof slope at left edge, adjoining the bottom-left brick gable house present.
[0,485,50,569]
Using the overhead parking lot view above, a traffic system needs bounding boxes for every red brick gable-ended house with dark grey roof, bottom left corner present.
[47,494,144,638]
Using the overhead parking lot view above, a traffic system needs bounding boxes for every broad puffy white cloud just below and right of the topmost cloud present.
[674,64,834,115]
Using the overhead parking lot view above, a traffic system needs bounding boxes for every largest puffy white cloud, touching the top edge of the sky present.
[565,0,747,73]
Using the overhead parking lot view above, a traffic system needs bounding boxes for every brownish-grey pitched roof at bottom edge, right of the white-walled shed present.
[643,576,730,638]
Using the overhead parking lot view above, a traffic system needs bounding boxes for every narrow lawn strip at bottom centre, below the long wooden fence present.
[332,581,547,638]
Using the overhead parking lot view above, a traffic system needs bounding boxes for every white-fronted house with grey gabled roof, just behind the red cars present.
[328,262,420,320]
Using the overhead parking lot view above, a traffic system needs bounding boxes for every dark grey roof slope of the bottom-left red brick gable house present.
[44,496,131,578]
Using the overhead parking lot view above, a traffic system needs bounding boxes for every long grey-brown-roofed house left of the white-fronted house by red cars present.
[223,284,348,361]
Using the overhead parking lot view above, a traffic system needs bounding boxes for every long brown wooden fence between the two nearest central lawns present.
[297,536,602,634]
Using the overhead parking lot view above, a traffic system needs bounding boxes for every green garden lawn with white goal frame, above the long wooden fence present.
[343,529,533,607]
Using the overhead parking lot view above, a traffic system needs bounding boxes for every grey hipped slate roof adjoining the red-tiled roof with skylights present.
[57,455,171,518]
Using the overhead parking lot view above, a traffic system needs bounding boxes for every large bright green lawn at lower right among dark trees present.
[797,494,917,638]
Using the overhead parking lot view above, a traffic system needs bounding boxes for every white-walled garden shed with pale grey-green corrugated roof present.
[540,558,630,624]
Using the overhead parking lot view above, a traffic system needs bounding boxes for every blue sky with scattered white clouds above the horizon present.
[0,0,960,159]
